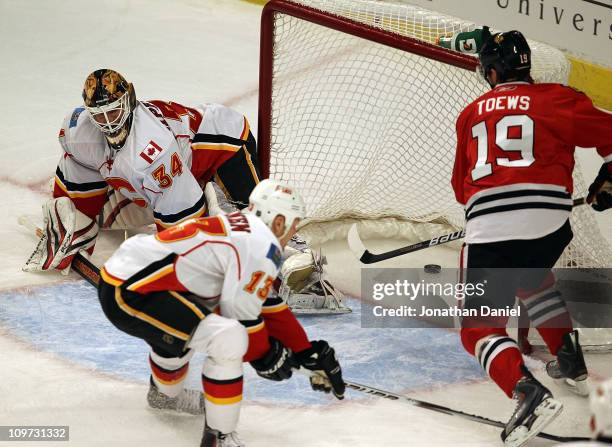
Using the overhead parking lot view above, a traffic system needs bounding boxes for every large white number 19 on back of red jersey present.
[471,115,535,181]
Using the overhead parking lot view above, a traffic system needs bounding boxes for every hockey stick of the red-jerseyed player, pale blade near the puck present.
[347,197,586,264]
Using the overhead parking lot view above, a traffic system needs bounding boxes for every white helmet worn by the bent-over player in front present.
[248,179,306,233]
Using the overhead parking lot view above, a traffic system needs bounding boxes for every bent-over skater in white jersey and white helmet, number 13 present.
[99,180,344,447]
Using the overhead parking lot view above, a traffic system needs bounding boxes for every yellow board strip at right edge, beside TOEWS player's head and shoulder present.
[566,55,612,111]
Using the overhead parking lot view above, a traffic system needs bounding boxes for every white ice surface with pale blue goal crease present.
[0,0,612,447]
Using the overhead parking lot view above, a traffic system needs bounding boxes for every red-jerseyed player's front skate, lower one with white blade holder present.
[501,368,563,447]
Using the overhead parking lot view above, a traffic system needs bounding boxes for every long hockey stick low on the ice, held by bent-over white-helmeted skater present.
[296,368,590,442]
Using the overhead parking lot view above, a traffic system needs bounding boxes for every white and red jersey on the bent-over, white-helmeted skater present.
[100,212,310,360]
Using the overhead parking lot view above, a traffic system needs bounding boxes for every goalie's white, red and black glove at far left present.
[23,197,98,273]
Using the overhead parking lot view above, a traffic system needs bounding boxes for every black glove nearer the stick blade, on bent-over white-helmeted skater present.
[295,340,346,399]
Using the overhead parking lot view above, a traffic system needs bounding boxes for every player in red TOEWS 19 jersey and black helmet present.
[452,31,612,446]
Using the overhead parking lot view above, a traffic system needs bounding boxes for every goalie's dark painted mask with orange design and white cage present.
[83,68,136,149]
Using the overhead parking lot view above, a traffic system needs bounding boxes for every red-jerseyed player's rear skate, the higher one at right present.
[546,330,590,396]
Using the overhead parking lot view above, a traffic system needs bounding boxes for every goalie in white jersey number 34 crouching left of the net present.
[25,69,344,312]
